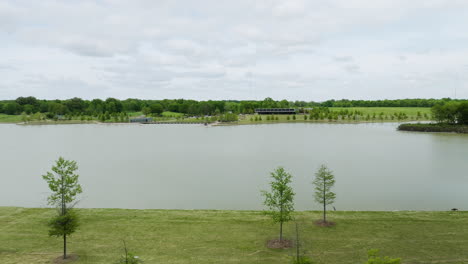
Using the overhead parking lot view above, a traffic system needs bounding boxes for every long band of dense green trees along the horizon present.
[0,96,466,117]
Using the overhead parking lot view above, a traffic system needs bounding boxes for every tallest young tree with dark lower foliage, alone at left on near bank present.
[42,157,82,259]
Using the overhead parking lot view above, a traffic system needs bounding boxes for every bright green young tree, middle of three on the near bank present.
[262,167,294,241]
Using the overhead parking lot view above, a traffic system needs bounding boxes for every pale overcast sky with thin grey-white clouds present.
[0,0,468,101]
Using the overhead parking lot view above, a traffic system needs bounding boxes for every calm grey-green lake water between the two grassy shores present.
[0,124,468,210]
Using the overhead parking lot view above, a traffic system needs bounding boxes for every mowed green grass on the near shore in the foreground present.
[0,207,468,264]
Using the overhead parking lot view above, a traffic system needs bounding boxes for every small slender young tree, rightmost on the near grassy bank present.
[313,165,336,223]
